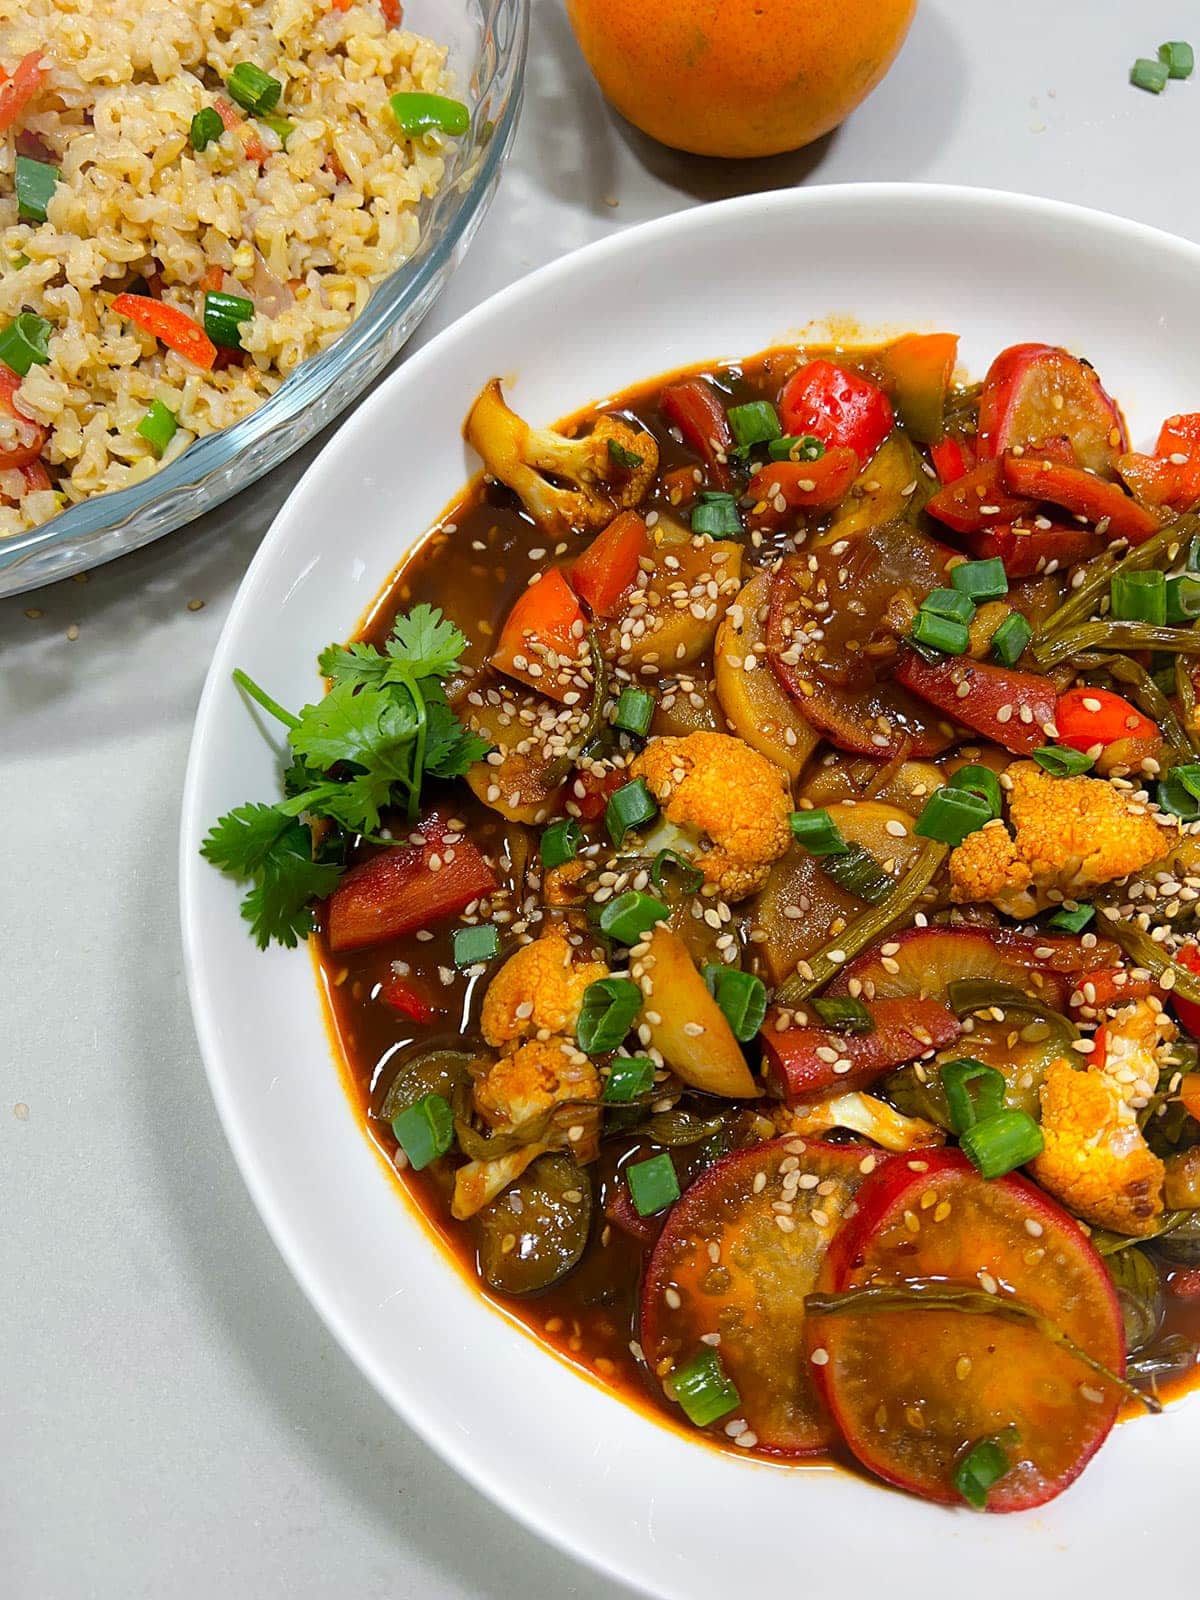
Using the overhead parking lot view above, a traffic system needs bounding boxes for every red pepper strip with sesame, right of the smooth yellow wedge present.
[760,998,962,1106]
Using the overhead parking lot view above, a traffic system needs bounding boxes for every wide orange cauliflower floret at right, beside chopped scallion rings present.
[950,762,1173,918]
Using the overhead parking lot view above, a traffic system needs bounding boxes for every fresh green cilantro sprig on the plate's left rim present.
[200,605,490,949]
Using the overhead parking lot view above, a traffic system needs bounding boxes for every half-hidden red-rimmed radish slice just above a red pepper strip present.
[826,928,1120,1010]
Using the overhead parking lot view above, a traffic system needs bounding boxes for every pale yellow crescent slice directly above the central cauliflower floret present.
[715,573,821,782]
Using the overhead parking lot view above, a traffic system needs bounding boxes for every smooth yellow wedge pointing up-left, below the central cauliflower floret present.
[642,923,758,1099]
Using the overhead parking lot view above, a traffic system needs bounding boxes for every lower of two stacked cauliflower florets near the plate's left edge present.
[451,1038,600,1222]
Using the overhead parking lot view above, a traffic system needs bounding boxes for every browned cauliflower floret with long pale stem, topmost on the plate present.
[464,378,658,531]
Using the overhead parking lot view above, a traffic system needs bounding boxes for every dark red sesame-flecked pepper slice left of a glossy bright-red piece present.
[893,650,1058,755]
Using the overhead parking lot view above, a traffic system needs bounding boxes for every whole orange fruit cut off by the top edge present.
[566,0,917,157]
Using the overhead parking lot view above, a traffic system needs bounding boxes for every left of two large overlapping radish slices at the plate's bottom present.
[638,1138,885,1456]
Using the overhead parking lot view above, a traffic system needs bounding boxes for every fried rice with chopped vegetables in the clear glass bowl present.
[0,0,448,538]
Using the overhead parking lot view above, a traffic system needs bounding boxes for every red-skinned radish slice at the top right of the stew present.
[979,344,1128,474]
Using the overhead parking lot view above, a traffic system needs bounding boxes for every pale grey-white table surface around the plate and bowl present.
[0,0,1200,1600]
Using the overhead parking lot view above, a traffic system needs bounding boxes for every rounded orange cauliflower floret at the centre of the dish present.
[630,733,792,901]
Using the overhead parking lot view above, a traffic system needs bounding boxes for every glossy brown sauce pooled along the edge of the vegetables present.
[314,349,1200,1464]
